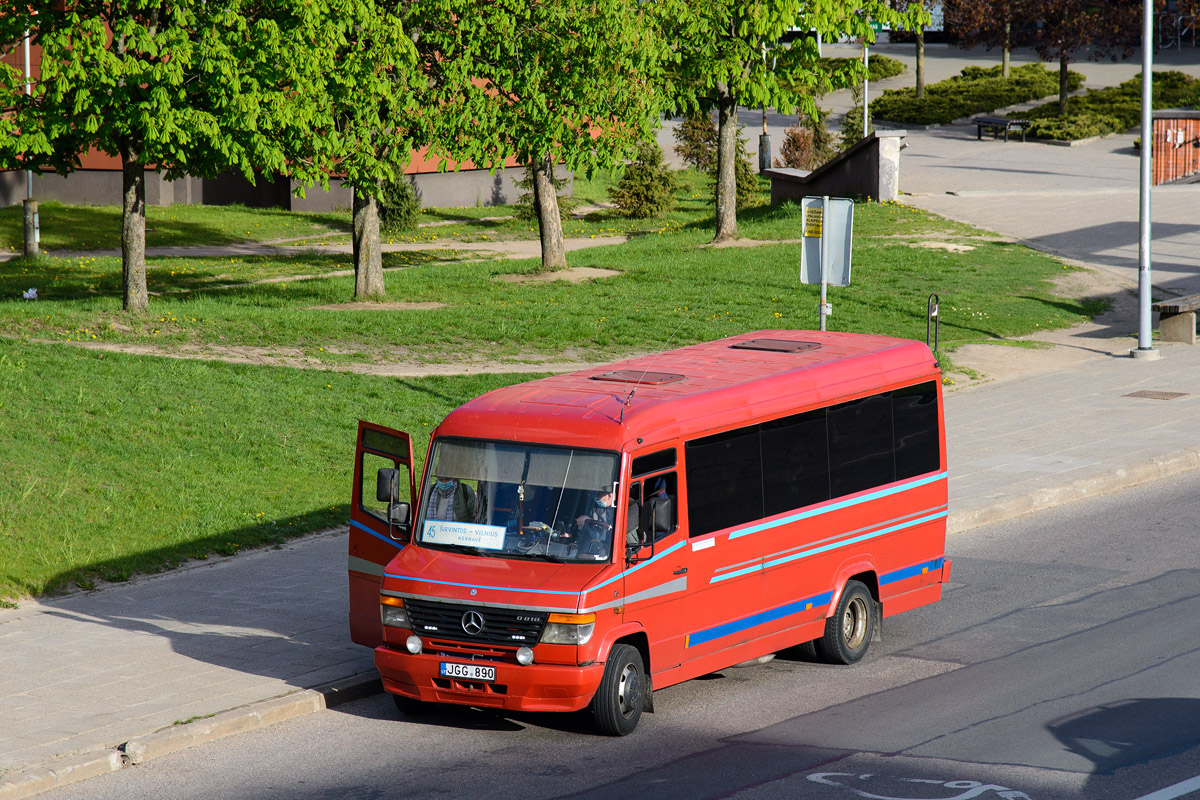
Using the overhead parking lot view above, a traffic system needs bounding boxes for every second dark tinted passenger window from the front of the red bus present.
[761,409,829,517]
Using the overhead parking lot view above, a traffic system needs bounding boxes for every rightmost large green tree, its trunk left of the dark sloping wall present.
[662,0,929,241]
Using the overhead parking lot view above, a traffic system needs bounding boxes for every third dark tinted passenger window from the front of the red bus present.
[828,395,895,498]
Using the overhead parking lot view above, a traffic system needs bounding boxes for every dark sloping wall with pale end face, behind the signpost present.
[763,131,907,205]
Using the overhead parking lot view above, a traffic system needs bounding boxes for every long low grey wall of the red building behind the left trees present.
[0,166,574,211]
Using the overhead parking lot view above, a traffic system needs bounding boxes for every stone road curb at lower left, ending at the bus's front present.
[0,675,383,800]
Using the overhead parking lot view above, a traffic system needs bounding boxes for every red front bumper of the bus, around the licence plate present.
[374,645,604,711]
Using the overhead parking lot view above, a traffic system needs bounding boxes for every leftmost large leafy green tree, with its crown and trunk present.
[0,0,331,312]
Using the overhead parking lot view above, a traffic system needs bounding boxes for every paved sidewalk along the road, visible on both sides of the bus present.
[7,345,1200,800]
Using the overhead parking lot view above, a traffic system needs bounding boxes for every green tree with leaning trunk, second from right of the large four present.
[427,0,667,270]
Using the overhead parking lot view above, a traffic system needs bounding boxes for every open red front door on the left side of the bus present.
[347,420,416,648]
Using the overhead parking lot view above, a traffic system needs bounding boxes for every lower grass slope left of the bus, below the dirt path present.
[0,339,527,597]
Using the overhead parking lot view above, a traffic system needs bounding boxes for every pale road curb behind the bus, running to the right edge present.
[946,449,1200,534]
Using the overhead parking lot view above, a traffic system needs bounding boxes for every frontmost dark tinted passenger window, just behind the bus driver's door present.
[685,426,762,536]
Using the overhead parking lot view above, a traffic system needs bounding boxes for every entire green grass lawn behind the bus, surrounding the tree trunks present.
[0,173,1098,597]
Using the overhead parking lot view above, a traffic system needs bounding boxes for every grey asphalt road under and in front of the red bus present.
[43,473,1200,800]
